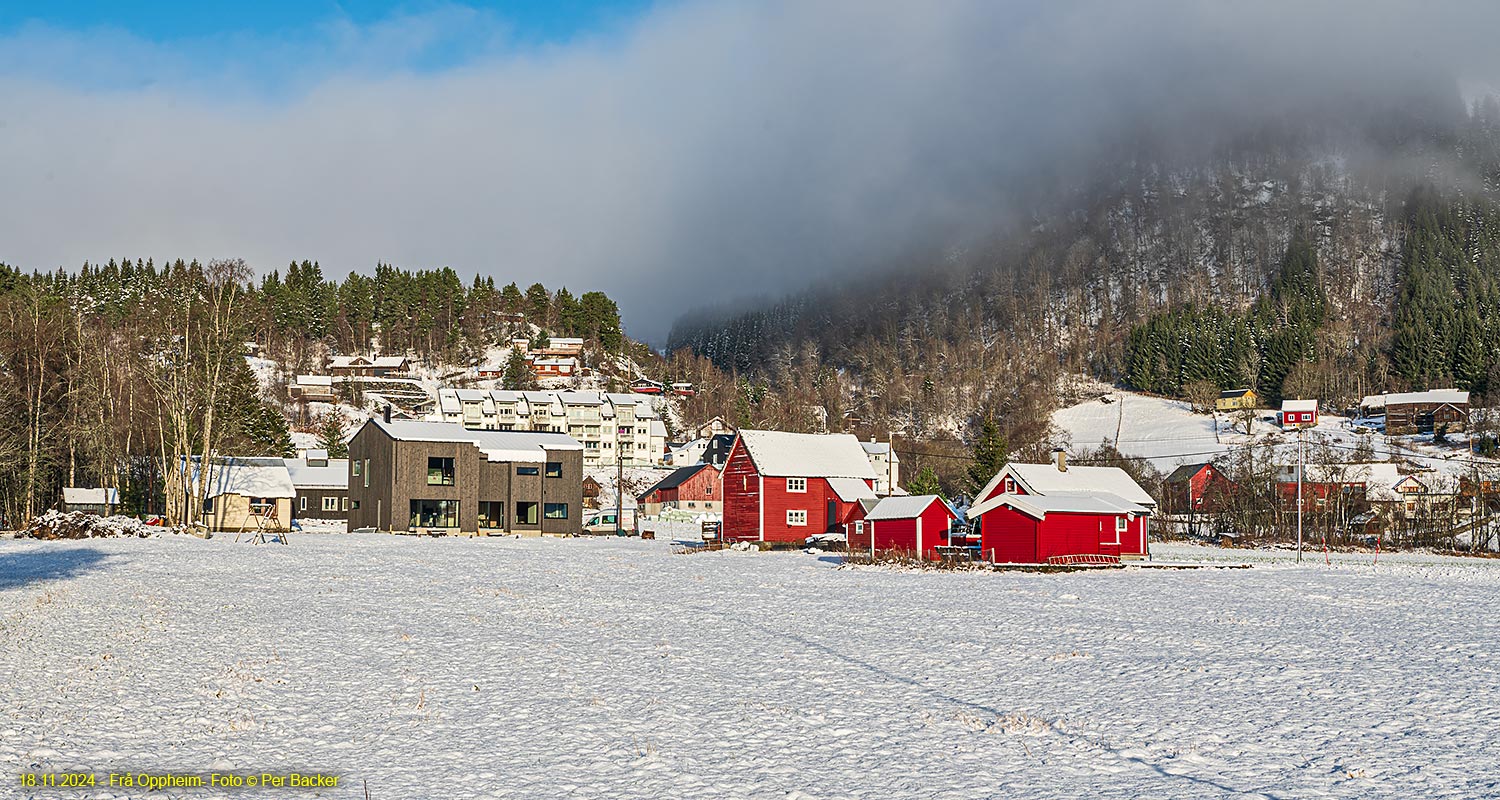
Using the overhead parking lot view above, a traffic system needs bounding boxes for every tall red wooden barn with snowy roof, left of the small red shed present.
[723,431,875,542]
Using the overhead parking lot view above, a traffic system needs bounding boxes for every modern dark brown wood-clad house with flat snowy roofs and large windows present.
[348,419,584,534]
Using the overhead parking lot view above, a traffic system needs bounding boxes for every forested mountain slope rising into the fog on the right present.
[669,99,1500,477]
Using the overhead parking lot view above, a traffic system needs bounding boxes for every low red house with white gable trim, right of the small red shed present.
[969,452,1157,564]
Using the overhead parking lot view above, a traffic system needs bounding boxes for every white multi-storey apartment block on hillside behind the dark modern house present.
[428,389,666,467]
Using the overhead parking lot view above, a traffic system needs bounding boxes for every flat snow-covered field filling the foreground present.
[0,534,1500,800]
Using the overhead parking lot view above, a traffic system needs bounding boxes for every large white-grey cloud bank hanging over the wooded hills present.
[0,0,1500,339]
